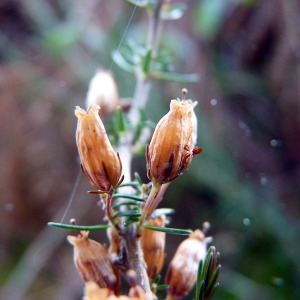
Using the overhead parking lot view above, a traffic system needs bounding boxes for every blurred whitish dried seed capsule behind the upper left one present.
[86,70,120,117]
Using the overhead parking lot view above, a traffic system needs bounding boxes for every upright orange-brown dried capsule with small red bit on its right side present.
[146,99,201,184]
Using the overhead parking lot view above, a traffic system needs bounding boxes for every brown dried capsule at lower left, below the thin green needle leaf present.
[68,231,120,292]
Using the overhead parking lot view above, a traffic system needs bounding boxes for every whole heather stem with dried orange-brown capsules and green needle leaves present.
[49,0,220,300]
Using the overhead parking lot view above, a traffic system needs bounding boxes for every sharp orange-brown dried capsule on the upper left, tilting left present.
[75,104,123,193]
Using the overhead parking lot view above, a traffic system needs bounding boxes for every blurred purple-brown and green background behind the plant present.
[0,0,300,300]
